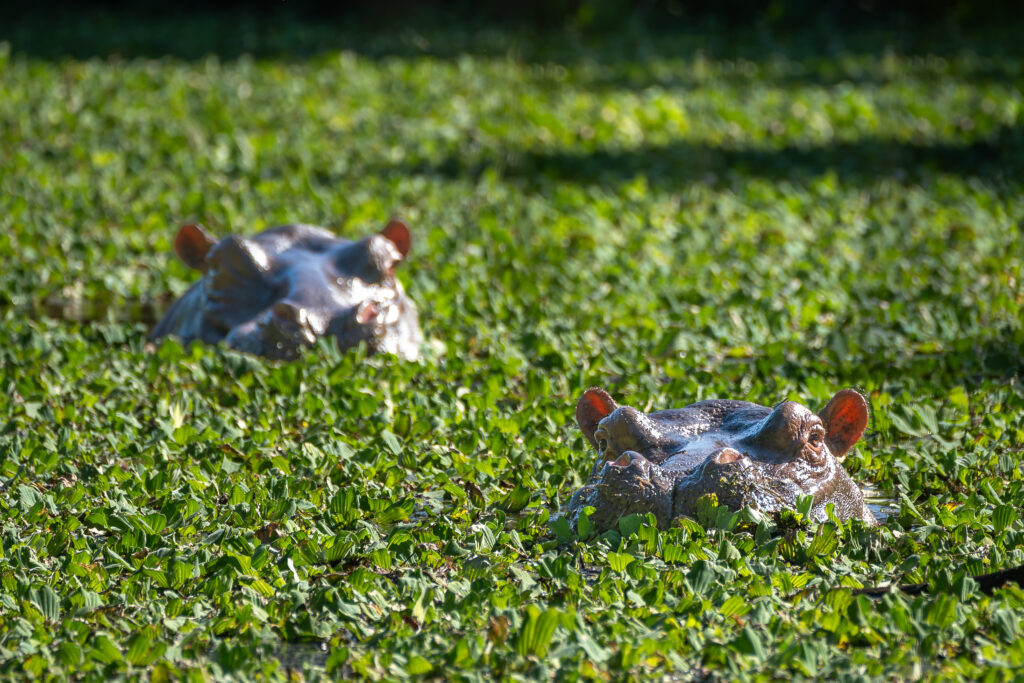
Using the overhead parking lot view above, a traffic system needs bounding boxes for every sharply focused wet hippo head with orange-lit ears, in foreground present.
[568,388,877,531]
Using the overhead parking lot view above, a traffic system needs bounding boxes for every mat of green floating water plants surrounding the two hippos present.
[0,15,1024,681]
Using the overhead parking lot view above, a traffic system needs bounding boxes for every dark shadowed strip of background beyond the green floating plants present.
[6,0,1020,58]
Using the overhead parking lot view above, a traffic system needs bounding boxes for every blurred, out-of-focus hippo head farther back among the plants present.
[152,220,423,360]
